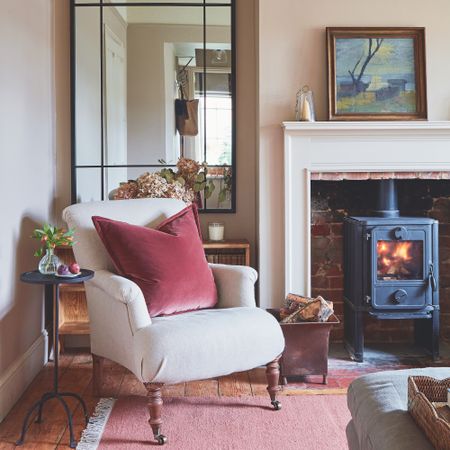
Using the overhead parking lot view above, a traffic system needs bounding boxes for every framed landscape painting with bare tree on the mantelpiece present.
[327,28,427,120]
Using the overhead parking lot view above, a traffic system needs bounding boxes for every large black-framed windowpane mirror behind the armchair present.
[71,0,236,213]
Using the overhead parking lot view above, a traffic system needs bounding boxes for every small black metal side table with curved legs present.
[16,269,94,448]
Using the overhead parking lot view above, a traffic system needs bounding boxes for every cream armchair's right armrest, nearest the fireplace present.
[209,264,258,308]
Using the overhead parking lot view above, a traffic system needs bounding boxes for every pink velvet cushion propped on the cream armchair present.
[92,207,217,317]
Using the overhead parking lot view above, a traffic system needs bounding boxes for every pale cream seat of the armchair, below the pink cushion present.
[136,308,284,384]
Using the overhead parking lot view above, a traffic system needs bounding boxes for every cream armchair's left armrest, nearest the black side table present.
[87,270,151,333]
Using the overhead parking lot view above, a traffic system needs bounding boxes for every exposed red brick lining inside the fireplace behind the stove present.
[311,179,450,342]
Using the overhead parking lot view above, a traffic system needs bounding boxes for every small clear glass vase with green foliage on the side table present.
[31,224,74,275]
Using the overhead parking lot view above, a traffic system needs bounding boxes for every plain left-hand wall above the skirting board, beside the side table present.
[0,0,55,376]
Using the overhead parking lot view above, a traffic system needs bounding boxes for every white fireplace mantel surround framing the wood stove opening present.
[283,121,450,295]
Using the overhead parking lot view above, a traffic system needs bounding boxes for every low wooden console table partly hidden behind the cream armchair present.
[55,239,250,352]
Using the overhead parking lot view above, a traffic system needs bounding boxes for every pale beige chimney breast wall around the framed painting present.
[259,0,450,306]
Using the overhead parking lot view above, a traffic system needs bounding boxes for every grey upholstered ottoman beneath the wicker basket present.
[347,367,450,450]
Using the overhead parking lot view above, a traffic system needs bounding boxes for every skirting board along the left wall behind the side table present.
[0,330,48,422]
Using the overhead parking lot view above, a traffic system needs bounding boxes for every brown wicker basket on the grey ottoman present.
[408,376,450,450]
